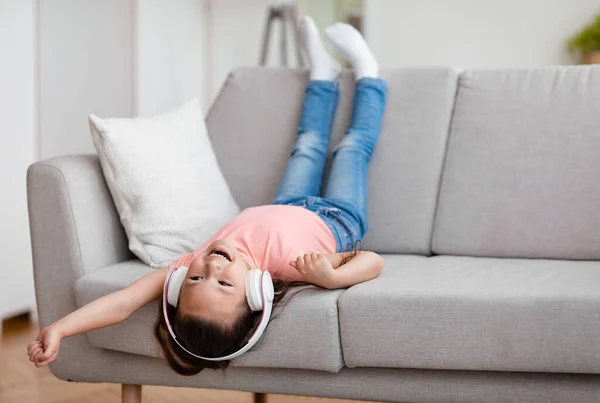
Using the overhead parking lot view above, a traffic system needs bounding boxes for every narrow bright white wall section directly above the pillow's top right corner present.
[133,0,206,116]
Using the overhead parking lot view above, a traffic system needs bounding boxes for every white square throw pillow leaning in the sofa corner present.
[90,99,239,267]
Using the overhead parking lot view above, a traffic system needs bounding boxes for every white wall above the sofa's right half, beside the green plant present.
[365,0,600,68]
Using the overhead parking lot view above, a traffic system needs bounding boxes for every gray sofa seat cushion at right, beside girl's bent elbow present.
[339,255,600,374]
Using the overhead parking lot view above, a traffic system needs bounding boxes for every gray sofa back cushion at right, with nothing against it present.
[432,66,600,259]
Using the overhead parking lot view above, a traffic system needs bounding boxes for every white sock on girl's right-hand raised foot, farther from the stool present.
[325,22,379,80]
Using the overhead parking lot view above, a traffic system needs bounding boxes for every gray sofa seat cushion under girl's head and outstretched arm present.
[75,260,343,372]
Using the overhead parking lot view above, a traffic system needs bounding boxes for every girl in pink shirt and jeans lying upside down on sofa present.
[27,18,386,375]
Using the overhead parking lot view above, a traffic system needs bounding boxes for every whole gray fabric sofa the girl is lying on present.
[28,66,600,403]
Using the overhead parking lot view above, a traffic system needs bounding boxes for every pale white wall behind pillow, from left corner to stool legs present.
[39,0,304,144]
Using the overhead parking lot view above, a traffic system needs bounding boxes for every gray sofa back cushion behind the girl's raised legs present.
[207,68,457,254]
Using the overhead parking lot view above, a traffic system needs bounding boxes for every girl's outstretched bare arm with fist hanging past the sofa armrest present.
[27,268,168,367]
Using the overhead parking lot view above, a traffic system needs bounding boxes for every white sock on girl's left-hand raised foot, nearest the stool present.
[299,17,340,81]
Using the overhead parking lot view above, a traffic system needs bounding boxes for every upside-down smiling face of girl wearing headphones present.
[178,239,250,326]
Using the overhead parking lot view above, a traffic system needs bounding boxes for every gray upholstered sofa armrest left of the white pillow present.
[27,155,132,327]
